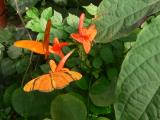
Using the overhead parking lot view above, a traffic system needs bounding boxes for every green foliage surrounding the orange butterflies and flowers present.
[0,0,160,120]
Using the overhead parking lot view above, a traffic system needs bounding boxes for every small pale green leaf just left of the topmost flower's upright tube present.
[67,13,79,29]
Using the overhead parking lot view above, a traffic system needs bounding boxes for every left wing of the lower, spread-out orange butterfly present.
[23,74,54,92]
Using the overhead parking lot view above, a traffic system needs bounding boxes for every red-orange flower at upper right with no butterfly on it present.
[71,13,97,54]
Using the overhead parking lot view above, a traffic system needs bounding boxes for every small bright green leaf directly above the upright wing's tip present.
[41,7,52,20]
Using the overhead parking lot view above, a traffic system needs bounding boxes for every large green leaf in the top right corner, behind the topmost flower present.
[95,0,160,43]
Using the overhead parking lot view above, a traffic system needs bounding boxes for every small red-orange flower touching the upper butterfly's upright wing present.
[49,38,68,58]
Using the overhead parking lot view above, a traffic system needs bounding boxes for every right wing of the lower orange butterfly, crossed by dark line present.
[53,70,82,89]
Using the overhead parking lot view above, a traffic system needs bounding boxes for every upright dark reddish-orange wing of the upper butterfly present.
[43,20,51,58]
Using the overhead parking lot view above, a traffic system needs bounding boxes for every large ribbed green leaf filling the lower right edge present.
[115,16,160,120]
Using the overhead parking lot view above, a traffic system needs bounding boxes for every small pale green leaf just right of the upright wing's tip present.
[51,10,63,26]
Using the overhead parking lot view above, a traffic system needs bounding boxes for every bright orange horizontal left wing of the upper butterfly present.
[14,40,45,54]
